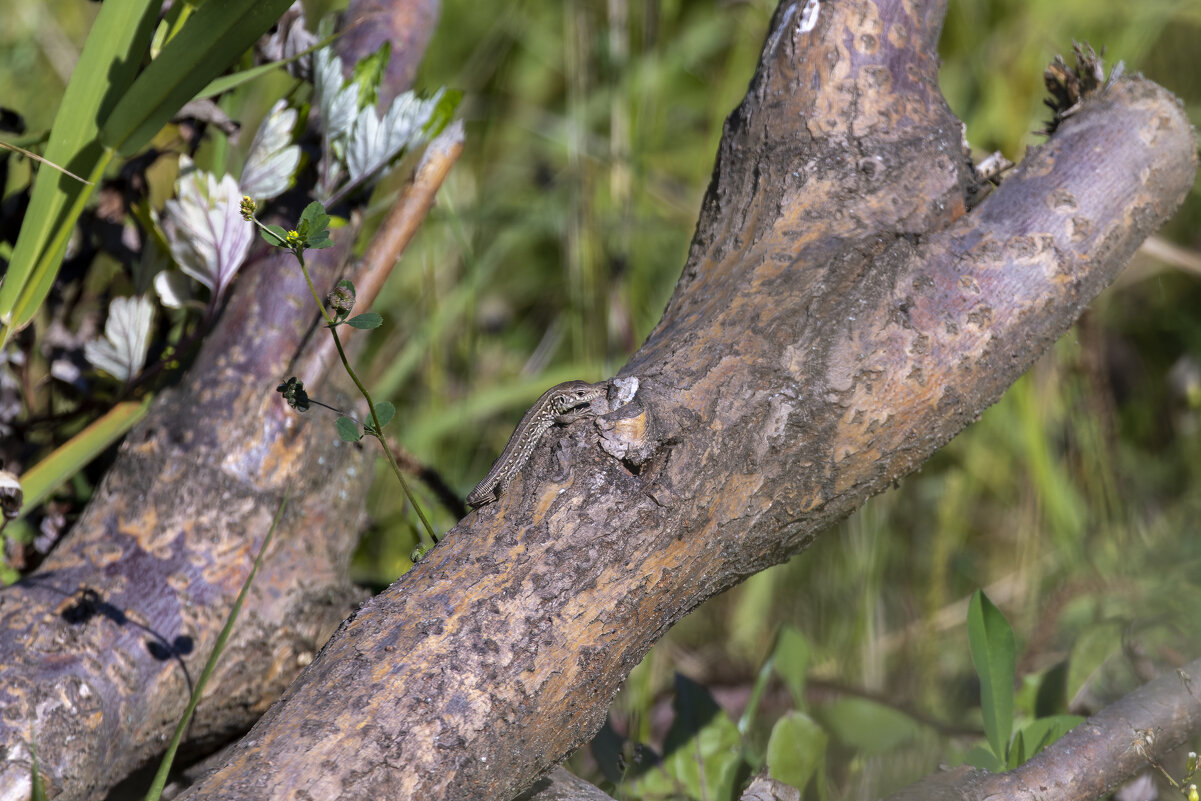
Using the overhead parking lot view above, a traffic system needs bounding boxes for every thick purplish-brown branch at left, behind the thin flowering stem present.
[0,0,441,801]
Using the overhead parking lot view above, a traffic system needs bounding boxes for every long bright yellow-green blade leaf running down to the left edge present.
[0,0,160,347]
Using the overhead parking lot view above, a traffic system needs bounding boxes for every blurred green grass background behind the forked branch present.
[0,0,1201,799]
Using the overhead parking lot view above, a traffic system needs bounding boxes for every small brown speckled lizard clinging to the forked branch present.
[467,381,608,508]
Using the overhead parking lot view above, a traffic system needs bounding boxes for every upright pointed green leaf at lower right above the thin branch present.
[968,590,1017,763]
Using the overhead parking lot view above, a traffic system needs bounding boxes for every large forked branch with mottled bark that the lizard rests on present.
[174,0,1196,800]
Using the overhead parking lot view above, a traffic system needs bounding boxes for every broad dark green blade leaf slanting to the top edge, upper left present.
[100,0,299,156]
